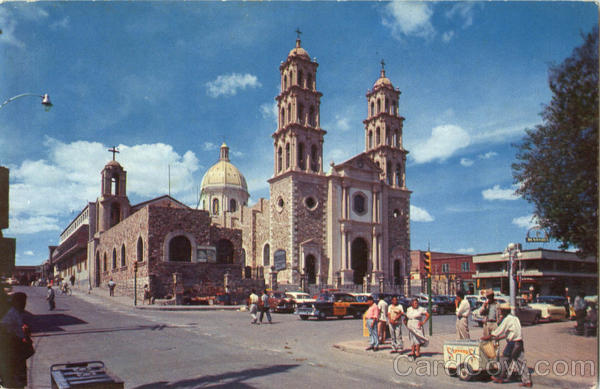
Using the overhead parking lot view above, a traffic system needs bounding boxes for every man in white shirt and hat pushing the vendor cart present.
[481,304,533,387]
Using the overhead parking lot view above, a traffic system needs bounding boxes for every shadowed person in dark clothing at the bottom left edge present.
[0,292,35,388]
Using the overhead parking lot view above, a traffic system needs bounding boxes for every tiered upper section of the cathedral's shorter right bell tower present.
[363,61,408,189]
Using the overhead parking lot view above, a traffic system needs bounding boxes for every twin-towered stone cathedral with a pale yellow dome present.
[200,38,411,288]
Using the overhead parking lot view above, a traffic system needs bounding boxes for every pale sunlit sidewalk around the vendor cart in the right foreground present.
[333,321,598,388]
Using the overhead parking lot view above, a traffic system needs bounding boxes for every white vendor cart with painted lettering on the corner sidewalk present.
[444,339,500,381]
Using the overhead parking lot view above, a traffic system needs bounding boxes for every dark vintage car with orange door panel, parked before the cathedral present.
[295,292,369,320]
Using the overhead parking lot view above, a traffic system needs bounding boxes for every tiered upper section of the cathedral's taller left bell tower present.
[273,31,326,177]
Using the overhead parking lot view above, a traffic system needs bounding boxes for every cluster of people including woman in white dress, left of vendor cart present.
[365,296,429,358]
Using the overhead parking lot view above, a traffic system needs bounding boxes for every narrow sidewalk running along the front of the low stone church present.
[73,288,245,311]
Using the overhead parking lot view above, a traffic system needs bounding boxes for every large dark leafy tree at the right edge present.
[512,26,599,256]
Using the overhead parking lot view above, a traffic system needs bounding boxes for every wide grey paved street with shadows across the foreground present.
[16,287,548,388]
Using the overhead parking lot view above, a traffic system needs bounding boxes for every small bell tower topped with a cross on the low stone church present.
[96,147,130,232]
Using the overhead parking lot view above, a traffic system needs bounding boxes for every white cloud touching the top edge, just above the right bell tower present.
[382,1,435,39]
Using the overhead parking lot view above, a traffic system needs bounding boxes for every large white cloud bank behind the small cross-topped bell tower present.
[10,138,200,233]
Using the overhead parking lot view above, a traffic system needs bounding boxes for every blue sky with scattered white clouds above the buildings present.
[0,1,598,265]
